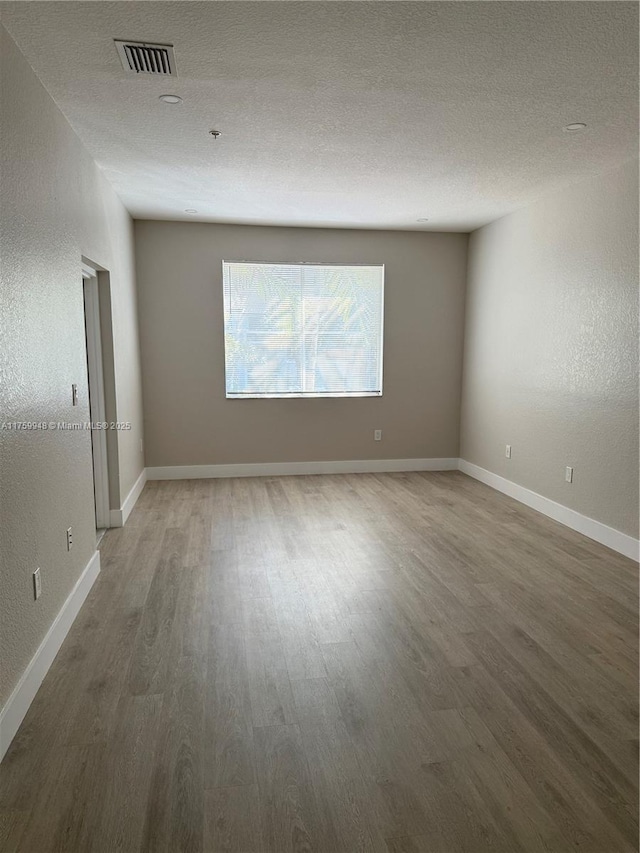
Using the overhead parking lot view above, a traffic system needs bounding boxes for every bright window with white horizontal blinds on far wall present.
[222,261,384,398]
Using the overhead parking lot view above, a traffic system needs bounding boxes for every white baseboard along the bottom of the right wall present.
[460,459,640,561]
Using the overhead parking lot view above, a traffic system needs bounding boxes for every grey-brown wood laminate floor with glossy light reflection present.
[0,473,638,853]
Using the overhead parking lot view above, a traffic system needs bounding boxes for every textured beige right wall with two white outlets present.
[461,156,638,536]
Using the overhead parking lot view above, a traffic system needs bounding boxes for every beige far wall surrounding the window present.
[135,221,467,466]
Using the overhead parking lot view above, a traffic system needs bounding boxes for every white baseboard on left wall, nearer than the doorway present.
[0,551,100,761]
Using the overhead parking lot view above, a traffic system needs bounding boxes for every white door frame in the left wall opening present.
[82,262,110,530]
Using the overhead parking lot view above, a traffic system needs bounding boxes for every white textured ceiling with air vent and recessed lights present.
[1,0,638,231]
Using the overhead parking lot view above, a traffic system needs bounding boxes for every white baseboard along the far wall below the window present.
[147,459,458,480]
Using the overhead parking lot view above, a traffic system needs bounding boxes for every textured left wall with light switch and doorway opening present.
[0,27,143,705]
